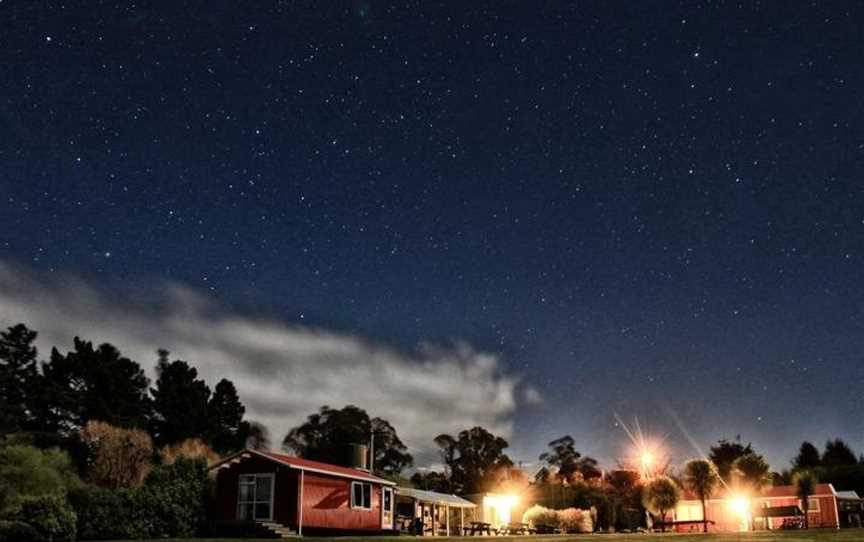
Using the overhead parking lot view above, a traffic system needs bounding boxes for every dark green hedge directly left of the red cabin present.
[71,458,207,539]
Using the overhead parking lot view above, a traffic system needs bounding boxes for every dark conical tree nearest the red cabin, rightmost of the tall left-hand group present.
[206,378,250,454]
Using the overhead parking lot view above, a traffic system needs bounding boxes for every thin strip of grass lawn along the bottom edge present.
[101,529,864,542]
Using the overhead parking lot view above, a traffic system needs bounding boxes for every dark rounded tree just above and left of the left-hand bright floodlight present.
[435,427,513,494]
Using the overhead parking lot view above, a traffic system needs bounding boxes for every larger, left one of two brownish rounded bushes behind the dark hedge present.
[81,420,153,488]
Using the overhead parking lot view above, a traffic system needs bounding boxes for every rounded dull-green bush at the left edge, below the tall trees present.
[0,445,80,513]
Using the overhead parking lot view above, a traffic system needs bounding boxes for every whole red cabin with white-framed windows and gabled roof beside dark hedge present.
[211,450,395,534]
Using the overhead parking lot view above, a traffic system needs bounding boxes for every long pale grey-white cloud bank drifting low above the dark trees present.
[0,261,528,465]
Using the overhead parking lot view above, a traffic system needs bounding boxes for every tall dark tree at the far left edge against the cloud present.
[0,324,39,438]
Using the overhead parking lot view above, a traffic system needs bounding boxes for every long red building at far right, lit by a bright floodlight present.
[672,484,861,532]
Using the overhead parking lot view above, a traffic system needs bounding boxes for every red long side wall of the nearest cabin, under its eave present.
[303,472,381,530]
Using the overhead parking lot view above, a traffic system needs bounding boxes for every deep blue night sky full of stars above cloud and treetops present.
[0,0,864,468]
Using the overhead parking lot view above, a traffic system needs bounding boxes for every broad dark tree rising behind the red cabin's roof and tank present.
[282,405,413,475]
